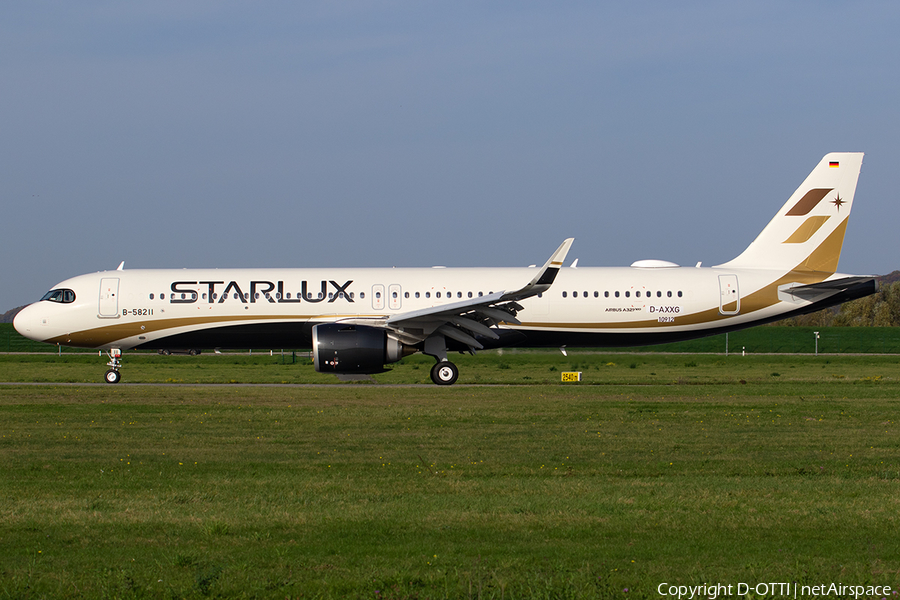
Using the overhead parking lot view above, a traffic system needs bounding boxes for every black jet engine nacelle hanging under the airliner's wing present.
[312,323,408,373]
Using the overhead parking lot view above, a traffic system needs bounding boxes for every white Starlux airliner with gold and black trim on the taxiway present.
[14,152,877,385]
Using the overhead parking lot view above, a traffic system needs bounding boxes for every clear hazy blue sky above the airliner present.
[0,1,900,311]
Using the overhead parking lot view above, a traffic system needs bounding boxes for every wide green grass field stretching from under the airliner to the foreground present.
[0,352,900,598]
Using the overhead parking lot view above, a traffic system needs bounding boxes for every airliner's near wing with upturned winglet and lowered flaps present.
[385,238,574,350]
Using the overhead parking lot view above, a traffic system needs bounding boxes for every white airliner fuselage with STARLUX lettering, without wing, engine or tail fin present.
[16,267,821,349]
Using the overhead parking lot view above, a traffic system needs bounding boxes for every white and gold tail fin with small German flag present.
[719,152,863,273]
